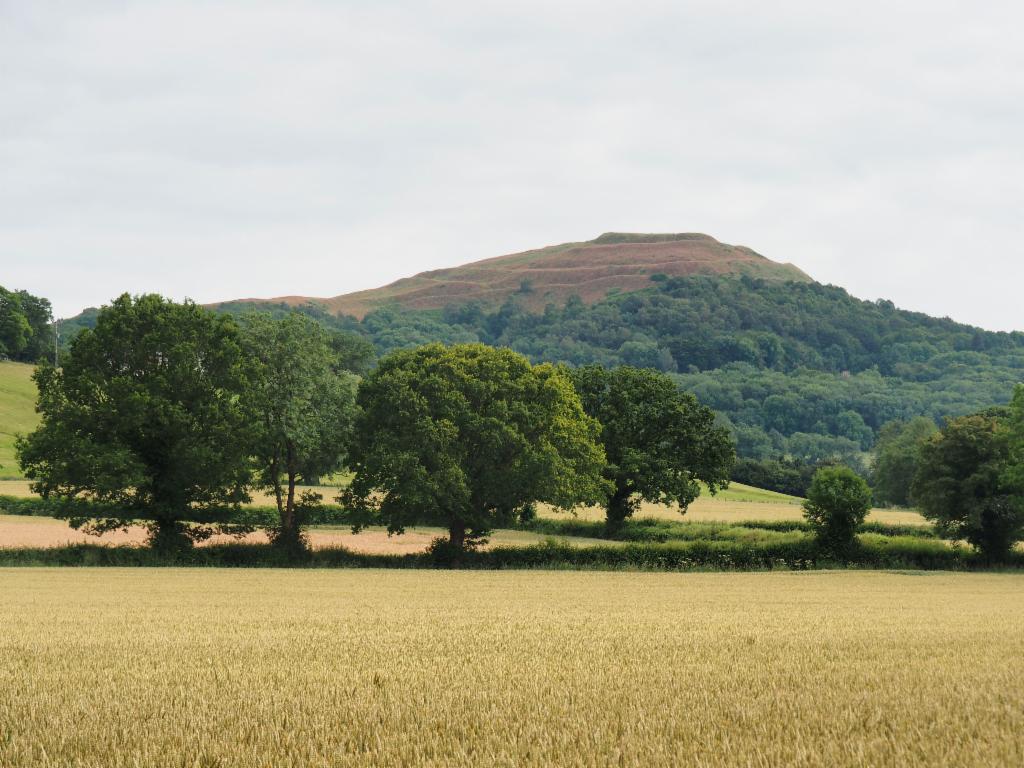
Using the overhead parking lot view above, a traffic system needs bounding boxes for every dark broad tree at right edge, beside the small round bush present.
[913,410,1024,561]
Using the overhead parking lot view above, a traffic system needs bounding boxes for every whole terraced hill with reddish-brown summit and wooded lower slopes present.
[58,228,1024,473]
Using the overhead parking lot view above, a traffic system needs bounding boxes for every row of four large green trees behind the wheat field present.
[17,295,734,556]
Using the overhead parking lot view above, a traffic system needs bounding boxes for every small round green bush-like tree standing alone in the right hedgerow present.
[804,467,871,557]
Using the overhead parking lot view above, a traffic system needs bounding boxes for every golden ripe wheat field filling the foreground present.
[0,568,1024,768]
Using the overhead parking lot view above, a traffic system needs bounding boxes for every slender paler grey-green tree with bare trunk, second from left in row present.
[243,312,358,552]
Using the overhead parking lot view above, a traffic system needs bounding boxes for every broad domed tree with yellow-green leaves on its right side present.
[342,344,605,551]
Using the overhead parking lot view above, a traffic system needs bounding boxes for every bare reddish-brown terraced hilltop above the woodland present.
[222,232,811,318]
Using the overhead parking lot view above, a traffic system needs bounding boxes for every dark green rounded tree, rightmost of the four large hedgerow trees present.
[572,366,735,530]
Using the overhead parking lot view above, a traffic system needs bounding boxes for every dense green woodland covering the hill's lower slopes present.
[203,275,1024,469]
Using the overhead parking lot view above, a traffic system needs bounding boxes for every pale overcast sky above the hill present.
[0,0,1024,330]
